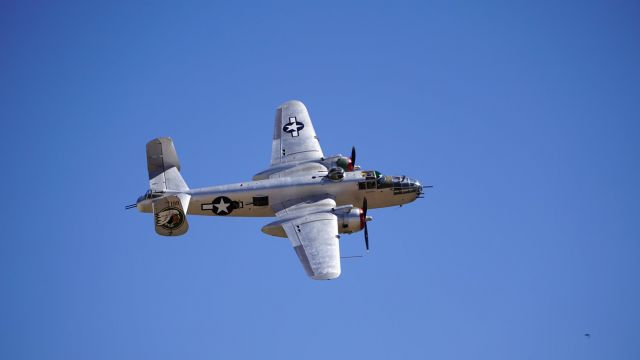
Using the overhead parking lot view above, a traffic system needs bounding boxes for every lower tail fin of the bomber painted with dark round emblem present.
[152,194,191,236]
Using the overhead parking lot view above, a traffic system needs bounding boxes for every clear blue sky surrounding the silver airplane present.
[0,1,640,360]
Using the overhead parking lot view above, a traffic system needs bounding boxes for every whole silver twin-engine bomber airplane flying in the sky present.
[127,100,423,280]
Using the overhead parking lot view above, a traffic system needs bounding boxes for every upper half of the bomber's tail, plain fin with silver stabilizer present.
[147,137,189,192]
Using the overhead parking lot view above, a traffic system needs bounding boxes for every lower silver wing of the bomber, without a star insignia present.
[277,198,340,280]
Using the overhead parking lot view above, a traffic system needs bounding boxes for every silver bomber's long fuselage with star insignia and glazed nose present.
[137,171,422,217]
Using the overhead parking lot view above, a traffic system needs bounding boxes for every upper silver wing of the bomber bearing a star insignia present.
[271,100,324,166]
